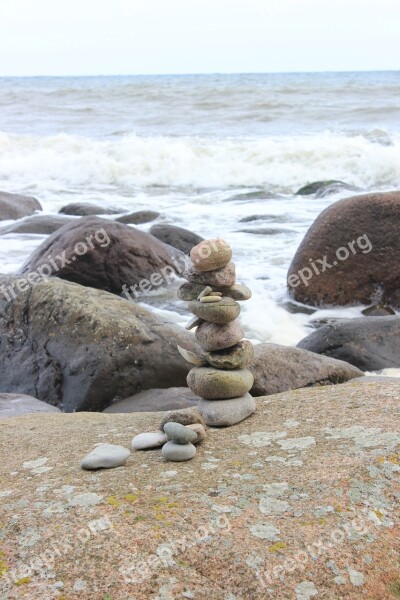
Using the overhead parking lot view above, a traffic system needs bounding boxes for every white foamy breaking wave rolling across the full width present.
[0,132,400,193]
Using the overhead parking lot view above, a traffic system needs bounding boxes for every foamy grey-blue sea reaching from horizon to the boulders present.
[0,71,400,354]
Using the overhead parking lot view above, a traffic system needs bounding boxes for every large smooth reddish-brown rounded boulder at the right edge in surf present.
[288,191,400,307]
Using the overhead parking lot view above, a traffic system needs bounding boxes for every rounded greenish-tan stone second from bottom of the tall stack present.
[187,367,254,400]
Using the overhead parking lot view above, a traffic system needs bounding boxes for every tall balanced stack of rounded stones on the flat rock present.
[178,239,256,427]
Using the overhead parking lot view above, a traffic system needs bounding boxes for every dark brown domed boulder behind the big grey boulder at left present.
[21,217,184,297]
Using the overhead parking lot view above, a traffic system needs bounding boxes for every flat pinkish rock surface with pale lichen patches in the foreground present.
[0,380,400,600]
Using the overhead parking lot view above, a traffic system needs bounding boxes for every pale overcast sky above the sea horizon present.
[0,0,400,75]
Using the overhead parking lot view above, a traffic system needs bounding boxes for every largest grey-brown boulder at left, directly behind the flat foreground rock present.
[0,276,199,412]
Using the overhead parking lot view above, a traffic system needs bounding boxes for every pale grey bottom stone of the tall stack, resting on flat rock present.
[199,394,257,427]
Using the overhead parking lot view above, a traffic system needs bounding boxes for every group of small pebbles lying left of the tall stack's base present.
[81,412,206,470]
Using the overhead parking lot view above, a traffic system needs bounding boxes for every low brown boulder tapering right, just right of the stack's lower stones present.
[249,344,363,396]
